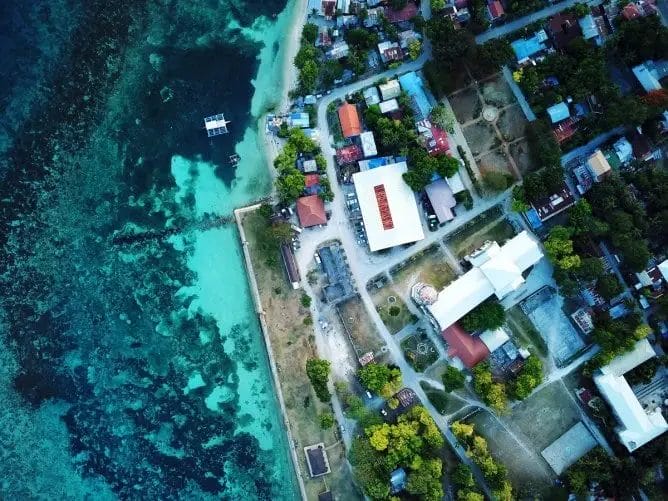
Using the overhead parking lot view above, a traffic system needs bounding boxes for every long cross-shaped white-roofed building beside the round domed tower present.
[427,231,543,329]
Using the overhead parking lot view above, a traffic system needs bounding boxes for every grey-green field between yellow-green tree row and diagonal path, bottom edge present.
[466,411,552,499]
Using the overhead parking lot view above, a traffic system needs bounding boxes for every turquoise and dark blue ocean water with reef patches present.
[0,0,298,500]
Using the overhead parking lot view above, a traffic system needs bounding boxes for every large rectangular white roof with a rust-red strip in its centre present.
[353,162,424,252]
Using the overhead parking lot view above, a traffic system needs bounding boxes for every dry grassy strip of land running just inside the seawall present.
[243,212,359,499]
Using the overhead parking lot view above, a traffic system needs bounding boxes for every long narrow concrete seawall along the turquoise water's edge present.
[234,204,306,501]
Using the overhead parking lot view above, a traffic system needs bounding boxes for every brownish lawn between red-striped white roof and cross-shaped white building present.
[390,245,457,295]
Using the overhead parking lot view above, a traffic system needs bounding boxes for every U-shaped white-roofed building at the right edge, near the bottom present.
[594,339,668,452]
